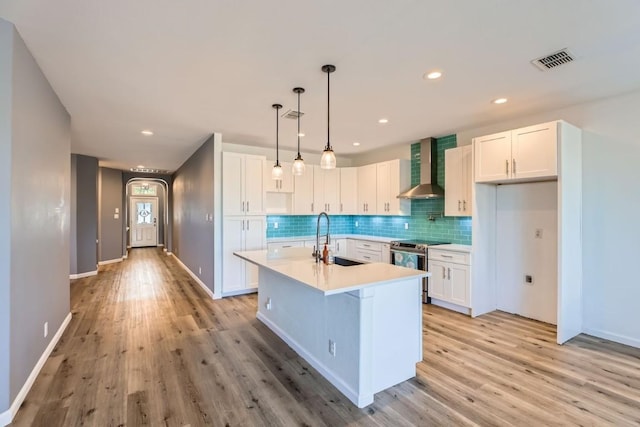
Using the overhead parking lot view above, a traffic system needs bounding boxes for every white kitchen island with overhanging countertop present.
[235,248,430,408]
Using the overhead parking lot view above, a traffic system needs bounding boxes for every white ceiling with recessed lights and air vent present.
[0,0,640,170]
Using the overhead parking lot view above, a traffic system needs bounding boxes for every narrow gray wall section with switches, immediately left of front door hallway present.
[98,168,124,262]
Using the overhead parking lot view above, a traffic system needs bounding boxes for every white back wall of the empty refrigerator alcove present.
[496,182,558,324]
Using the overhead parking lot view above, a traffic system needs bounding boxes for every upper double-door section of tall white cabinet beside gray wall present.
[222,152,266,215]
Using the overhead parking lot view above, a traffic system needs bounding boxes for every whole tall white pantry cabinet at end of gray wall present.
[222,152,267,296]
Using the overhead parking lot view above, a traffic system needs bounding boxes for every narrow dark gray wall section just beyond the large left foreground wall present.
[71,154,98,274]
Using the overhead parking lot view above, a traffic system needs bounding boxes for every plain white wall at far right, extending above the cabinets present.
[458,91,640,347]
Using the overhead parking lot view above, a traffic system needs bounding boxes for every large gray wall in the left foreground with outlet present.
[0,20,71,412]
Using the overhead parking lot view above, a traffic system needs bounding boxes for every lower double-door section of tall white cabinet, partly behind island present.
[222,216,267,295]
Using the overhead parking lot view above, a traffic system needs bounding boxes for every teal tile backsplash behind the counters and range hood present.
[267,135,471,245]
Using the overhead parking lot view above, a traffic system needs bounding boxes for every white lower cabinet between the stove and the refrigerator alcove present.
[429,249,470,307]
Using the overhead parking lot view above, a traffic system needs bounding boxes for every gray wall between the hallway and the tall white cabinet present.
[172,136,214,292]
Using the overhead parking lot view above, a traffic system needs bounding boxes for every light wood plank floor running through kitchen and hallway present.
[14,249,640,426]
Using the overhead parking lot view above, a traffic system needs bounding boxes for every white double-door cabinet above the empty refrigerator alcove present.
[473,122,558,183]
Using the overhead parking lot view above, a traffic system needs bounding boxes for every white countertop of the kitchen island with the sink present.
[234,248,431,295]
